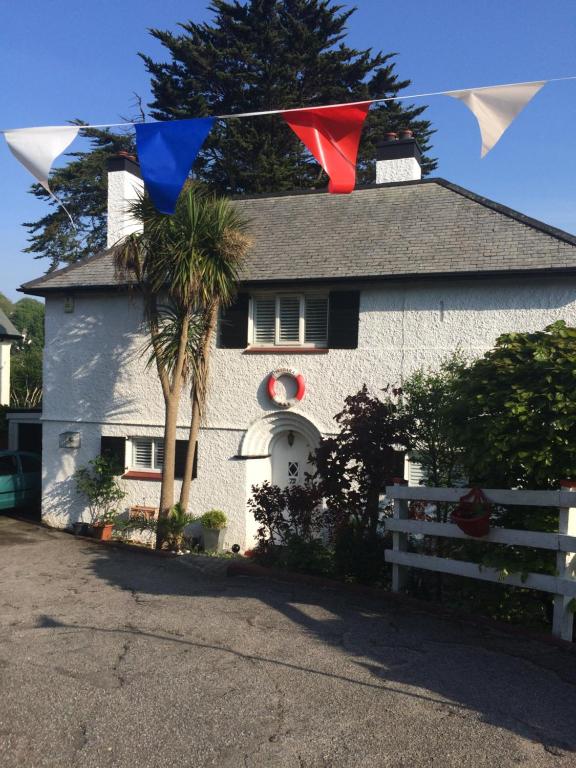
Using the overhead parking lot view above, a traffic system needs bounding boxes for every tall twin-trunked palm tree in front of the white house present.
[115,183,249,547]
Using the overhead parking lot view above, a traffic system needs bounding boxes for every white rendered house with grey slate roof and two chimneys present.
[22,138,576,546]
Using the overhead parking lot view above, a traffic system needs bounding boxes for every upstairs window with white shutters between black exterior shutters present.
[249,293,328,347]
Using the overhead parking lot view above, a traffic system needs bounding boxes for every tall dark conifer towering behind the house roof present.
[140,0,436,193]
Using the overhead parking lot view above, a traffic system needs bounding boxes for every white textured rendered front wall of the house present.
[43,277,576,546]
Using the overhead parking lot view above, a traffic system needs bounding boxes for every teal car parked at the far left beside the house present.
[0,451,42,509]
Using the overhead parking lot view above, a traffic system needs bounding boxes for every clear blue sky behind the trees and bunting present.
[0,0,576,300]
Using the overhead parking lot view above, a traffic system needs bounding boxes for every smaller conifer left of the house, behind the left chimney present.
[23,120,135,271]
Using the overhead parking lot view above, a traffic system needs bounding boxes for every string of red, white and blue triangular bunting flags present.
[0,75,576,216]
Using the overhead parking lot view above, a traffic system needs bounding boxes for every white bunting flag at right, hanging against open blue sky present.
[446,80,546,157]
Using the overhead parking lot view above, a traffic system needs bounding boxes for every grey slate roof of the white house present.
[21,179,576,295]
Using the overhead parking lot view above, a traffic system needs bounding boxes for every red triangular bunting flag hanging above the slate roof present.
[280,101,371,194]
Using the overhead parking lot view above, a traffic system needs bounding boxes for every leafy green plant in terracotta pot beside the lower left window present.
[74,456,126,541]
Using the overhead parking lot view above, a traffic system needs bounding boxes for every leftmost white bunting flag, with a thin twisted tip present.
[4,125,80,221]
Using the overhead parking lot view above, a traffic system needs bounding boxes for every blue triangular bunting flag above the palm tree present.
[134,117,214,213]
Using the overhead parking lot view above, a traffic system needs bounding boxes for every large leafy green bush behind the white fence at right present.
[456,320,576,489]
